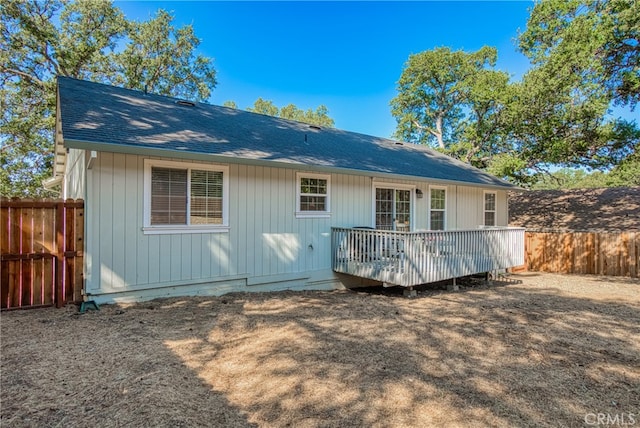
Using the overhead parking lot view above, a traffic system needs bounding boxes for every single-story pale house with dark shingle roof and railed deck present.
[49,77,523,302]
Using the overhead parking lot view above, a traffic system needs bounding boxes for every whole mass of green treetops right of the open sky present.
[391,0,640,185]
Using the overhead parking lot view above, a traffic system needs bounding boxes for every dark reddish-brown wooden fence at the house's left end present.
[0,198,84,309]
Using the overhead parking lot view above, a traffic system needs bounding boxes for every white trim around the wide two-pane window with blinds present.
[142,159,229,235]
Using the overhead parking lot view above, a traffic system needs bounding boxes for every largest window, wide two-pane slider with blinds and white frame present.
[143,159,229,233]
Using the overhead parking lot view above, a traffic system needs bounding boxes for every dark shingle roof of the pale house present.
[58,77,513,187]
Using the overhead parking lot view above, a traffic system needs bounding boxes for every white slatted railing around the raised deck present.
[331,227,525,287]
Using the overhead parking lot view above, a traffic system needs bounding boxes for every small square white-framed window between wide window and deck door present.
[296,173,331,218]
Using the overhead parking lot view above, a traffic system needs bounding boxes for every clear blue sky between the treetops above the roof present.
[115,1,533,137]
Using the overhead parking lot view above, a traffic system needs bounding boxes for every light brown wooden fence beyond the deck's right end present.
[512,231,640,278]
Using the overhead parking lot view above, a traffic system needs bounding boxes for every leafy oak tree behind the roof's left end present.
[0,0,216,196]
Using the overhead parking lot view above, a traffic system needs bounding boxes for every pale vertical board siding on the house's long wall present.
[80,150,507,301]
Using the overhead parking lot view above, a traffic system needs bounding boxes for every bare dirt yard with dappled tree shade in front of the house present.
[0,273,640,427]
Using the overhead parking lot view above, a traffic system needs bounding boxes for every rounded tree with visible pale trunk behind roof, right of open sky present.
[391,46,513,172]
